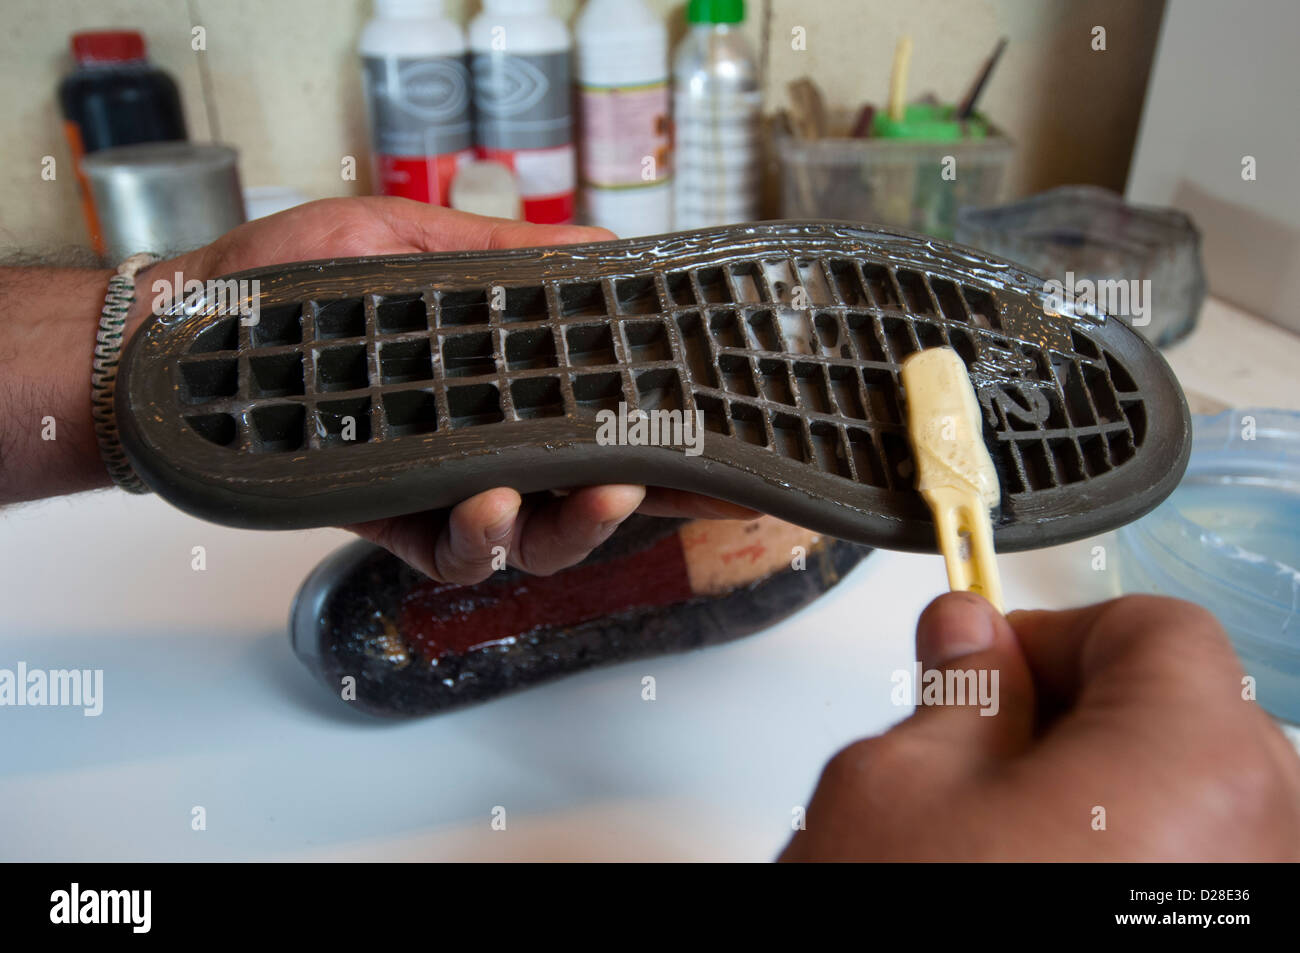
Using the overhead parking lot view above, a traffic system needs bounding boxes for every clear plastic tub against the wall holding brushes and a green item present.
[774,116,1015,238]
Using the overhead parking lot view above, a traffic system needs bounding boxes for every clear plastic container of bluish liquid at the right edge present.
[1119,408,1300,723]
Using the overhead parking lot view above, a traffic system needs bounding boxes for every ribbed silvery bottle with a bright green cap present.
[672,0,762,229]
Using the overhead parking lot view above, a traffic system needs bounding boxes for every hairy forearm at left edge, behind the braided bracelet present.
[0,268,120,506]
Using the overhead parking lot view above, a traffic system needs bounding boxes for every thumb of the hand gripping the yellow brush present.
[887,593,1035,771]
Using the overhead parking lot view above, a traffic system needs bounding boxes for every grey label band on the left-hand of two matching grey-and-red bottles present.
[361,56,473,159]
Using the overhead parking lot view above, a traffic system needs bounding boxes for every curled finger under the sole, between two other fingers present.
[512,485,645,576]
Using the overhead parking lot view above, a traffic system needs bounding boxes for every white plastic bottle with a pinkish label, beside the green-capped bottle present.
[573,0,672,238]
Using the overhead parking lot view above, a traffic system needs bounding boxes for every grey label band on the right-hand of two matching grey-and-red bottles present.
[471,51,573,150]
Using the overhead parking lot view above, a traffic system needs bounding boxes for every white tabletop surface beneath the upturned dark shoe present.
[0,295,1300,861]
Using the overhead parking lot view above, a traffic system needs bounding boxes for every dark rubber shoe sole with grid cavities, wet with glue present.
[116,222,1190,553]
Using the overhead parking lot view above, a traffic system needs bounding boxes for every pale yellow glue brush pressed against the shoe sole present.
[901,347,1002,612]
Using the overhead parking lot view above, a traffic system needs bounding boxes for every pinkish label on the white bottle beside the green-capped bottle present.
[579,82,672,189]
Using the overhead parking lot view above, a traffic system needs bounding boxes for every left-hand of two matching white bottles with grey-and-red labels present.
[360,0,473,205]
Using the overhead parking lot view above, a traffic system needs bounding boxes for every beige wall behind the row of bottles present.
[0,0,1164,248]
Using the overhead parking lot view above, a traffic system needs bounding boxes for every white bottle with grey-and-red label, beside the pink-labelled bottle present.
[469,0,575,224]
